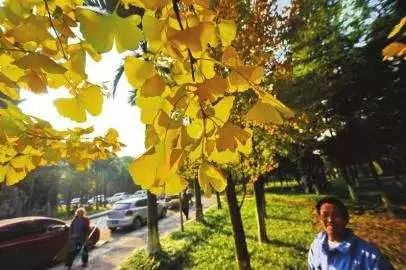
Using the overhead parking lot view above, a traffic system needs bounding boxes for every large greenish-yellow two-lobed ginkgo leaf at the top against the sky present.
[76,8,142,53]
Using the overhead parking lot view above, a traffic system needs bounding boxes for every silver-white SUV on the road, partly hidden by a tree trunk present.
[107,196,166,231]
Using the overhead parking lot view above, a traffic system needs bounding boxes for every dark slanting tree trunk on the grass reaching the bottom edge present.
[226,174,251,270]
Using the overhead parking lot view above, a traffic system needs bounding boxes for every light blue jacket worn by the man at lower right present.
[308,229,393,270]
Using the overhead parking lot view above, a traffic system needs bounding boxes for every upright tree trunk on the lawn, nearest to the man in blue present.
[254,176,269,243]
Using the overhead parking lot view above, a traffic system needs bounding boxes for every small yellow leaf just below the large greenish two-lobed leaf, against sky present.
[124,56,156,89]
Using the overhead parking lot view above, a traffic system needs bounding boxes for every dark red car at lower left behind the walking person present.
[0,217,100,269]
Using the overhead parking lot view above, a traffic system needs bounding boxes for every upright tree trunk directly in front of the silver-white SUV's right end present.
[147,191,161,256]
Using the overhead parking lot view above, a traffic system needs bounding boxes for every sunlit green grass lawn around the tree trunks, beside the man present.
[120,195,316,269]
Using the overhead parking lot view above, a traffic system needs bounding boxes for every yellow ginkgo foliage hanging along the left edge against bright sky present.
[0,1,122,185]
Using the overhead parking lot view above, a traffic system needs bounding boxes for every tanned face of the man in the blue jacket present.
[319,203,348,241]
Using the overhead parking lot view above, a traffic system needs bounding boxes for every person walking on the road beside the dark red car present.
[66,208,90,269]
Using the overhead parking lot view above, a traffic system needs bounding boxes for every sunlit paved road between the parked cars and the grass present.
[50,196,215,270]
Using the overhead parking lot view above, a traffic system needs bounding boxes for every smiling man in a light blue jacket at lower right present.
[308,197,393,270]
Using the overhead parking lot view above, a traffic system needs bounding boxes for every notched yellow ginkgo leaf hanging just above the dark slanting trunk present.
[198,162,227,197]
